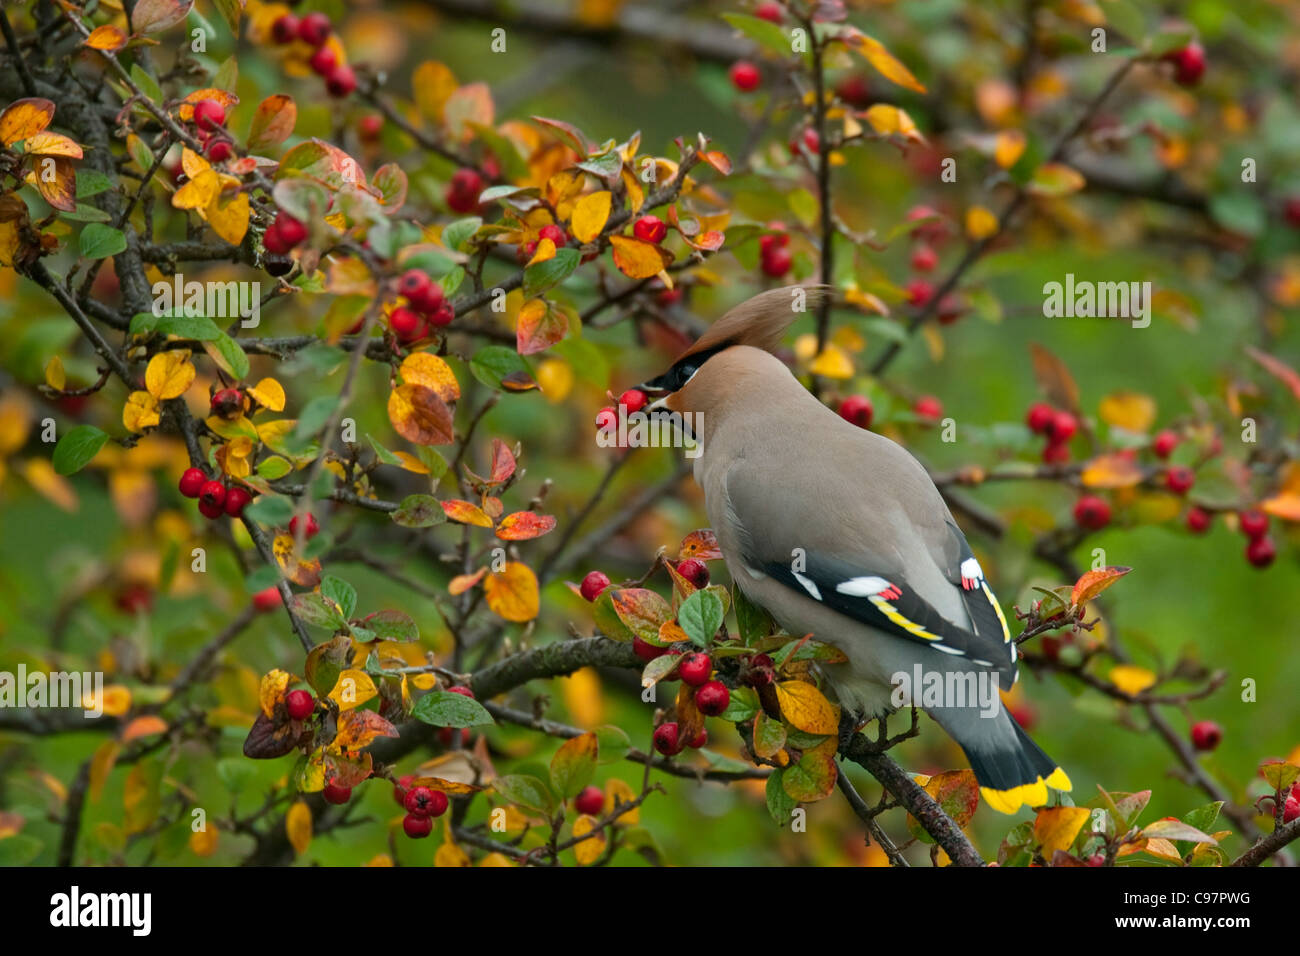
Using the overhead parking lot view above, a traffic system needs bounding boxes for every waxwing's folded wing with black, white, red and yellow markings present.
[725,459,1017,685]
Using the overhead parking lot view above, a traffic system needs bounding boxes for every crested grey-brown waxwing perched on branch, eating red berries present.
[629,289,1070,813]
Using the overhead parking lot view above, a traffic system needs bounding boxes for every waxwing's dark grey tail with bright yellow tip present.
[935,708,1071,813]
